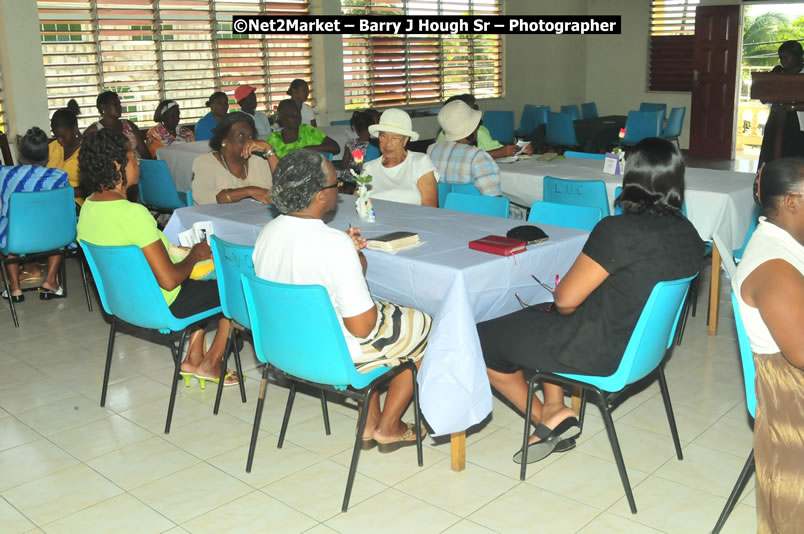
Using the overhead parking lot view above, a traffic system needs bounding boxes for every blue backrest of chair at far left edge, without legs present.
[2,185,76,256]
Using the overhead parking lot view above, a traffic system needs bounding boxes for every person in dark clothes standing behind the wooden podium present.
[758,41,804,168]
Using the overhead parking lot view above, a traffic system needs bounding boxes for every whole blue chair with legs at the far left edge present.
[0,185,92,327]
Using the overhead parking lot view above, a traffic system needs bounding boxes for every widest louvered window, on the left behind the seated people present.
[38,0,312,131]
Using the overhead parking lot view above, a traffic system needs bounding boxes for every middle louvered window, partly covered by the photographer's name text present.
[341,0,502,109]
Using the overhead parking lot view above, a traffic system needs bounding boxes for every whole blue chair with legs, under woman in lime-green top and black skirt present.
[81,241,225,434]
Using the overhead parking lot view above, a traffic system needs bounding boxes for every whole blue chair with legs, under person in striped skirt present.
[241,274,423,512]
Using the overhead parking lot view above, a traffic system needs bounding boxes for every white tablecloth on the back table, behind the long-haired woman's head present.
[500,159,754,250]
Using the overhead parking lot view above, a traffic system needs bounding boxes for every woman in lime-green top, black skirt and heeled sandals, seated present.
[78,128,238,386]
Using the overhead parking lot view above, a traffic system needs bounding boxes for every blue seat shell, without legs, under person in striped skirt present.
[241,274,390,389]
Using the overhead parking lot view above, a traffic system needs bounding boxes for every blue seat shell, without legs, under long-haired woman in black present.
[558,276,695,392]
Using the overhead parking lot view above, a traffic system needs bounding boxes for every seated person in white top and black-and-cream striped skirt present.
[253,150,432,452]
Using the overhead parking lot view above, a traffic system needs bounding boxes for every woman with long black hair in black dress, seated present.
[477,138,704,463]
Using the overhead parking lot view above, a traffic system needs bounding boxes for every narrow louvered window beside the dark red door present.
[648,0,700,91]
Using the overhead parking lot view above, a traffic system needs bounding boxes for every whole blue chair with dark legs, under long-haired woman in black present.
[519,277,693,514]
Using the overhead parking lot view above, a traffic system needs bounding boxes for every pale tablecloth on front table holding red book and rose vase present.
[165,195,588,435]
